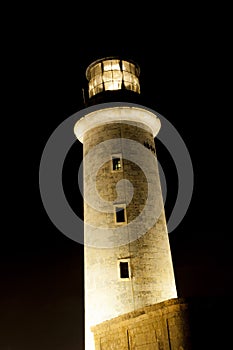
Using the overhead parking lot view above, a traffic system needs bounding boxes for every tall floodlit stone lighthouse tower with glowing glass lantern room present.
[74,57,178,350]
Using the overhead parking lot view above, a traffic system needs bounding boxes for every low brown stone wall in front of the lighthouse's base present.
[92,298,192,350]
